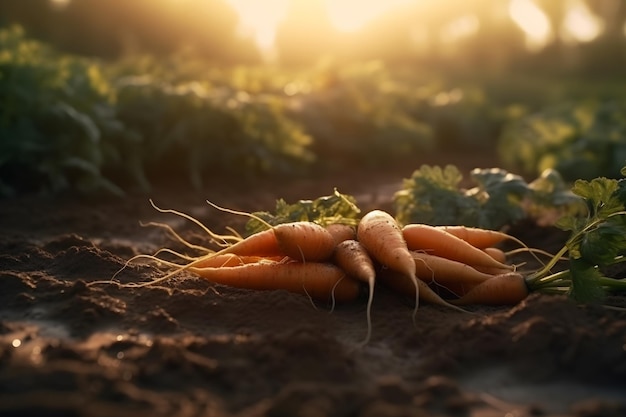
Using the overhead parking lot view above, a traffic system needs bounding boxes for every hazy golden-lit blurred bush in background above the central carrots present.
[291,62,435,166]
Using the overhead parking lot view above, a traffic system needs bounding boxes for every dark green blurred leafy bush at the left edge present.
[0,28,121,194]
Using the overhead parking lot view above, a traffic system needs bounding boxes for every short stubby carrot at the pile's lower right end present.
[450,272,530,305]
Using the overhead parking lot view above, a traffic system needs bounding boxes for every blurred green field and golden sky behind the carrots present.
[0,0,626,196]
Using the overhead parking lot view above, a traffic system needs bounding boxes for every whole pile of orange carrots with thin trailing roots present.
[100,202,544,340]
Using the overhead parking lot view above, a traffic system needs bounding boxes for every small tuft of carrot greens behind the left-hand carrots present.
[246,190,361,234]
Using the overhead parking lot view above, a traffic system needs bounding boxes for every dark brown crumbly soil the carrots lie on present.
[0,156,626,417]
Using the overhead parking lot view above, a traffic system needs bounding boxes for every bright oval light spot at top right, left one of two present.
[509,0,552,50]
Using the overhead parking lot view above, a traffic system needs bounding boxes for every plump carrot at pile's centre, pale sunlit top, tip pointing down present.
[357,210,420,321]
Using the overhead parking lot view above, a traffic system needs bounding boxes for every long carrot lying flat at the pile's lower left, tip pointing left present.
[187,261,359,302]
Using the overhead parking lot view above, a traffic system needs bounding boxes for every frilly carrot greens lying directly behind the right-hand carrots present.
[394,165,578,229]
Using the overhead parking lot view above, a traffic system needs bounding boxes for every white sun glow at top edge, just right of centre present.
[326,0,414,32]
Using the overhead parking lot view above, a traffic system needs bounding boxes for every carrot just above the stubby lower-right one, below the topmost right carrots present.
[411,252,493,286]
